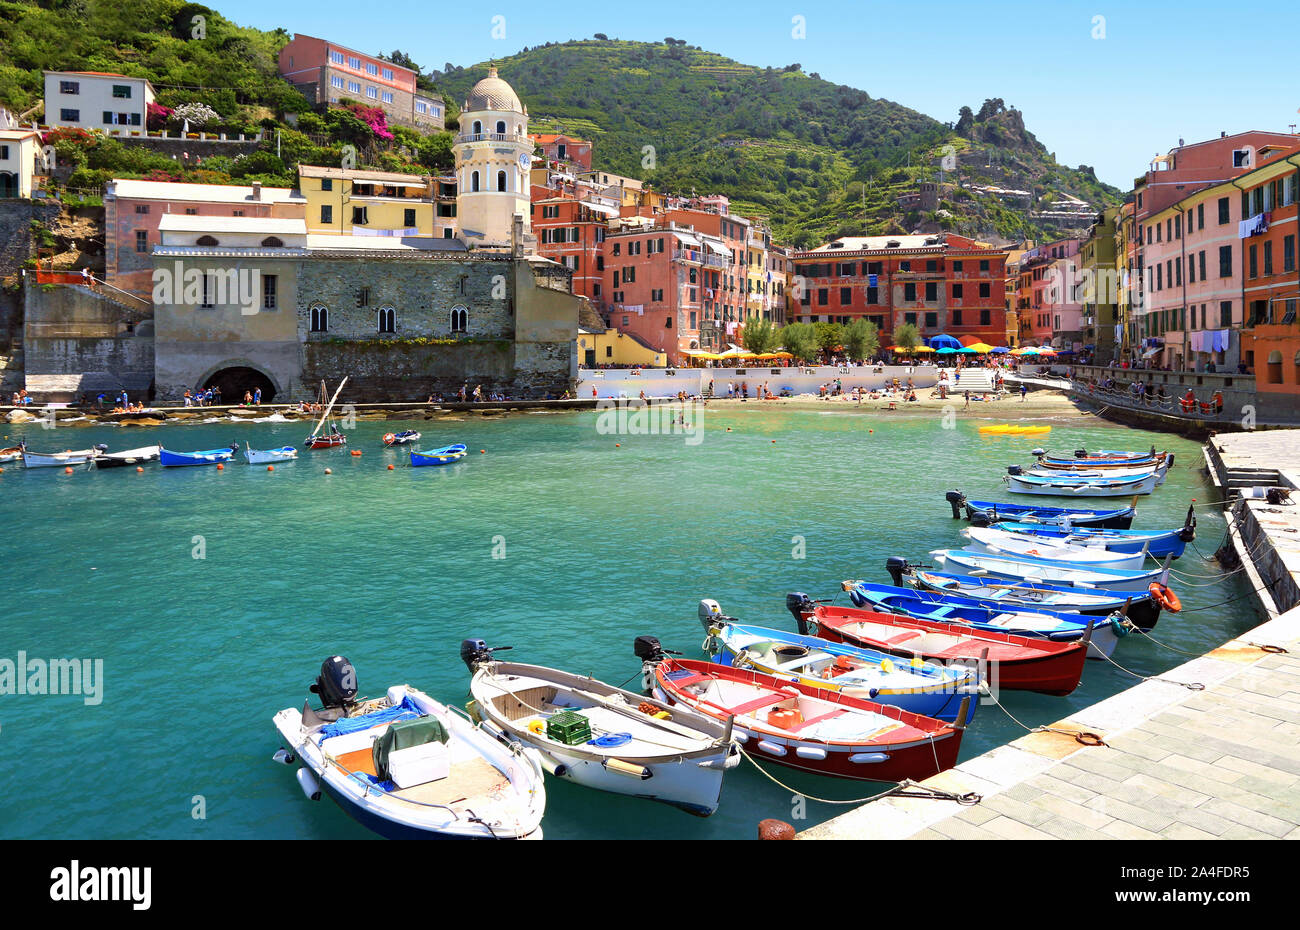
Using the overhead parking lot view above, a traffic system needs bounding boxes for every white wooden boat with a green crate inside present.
[460,640,740,817]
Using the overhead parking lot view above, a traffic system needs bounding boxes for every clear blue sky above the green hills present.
[212,0,1300,190]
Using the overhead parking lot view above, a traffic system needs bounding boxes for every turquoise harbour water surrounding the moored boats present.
[0,407,1258,839]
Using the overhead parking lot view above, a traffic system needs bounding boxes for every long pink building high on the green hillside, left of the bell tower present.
[280,34,443,131]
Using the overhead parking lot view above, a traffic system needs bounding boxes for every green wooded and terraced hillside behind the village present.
[0,6,1119,246]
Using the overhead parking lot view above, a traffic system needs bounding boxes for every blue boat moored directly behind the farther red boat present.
[841,581,1128,658]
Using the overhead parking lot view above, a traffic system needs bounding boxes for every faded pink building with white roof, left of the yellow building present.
[104,178,307,299]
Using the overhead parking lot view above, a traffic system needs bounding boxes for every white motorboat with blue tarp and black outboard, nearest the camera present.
[273,656,546,839]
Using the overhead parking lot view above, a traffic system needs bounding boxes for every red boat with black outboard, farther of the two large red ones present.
[787,594,1088,695]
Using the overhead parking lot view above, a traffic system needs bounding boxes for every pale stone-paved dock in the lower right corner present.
[798,431,1300,839]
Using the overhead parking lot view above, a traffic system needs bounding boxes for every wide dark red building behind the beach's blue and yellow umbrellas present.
[790,233,1006,346]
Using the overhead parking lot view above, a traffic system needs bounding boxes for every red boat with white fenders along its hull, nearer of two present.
[642,655,974,782]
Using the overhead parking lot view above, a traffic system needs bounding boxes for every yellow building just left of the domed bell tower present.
[298,165,458,239]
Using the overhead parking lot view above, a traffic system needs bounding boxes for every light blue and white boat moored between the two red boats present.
[699,600,979,723]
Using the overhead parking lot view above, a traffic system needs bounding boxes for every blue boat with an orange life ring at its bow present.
[885,557,1177,630]
